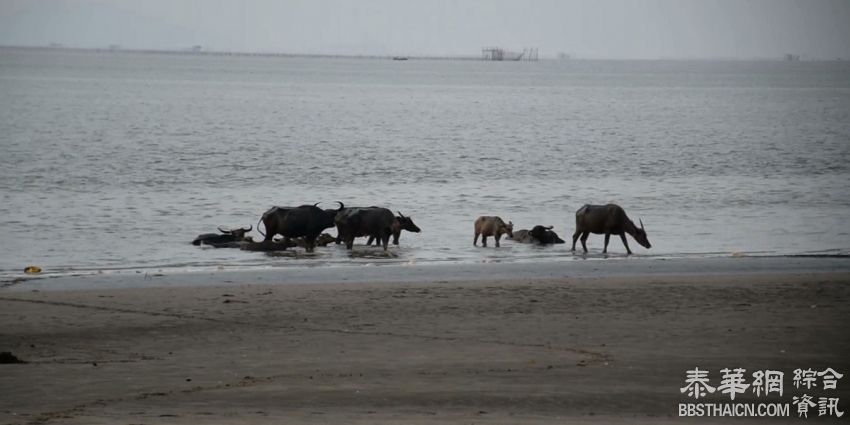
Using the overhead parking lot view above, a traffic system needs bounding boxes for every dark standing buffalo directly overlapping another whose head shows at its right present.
[336,207,395,251]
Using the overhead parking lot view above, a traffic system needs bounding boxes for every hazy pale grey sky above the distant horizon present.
[0,0,850,59]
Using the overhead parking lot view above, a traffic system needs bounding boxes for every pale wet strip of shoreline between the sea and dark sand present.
[0,256,850,293]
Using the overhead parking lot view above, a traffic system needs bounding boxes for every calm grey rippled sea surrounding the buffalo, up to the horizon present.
[0,48,850,278]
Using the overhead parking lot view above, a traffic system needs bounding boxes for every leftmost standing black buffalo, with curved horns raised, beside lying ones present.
[260,202,345,252]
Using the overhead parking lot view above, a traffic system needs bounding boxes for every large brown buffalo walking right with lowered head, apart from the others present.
[572,204,652,254]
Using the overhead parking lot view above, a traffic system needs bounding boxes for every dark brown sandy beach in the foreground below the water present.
[0,260,850,424]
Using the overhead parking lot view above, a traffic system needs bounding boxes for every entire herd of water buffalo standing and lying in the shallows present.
[192,202,651,254]
